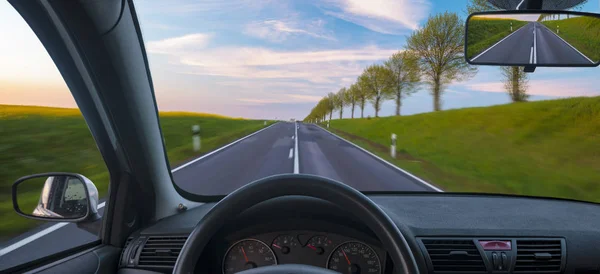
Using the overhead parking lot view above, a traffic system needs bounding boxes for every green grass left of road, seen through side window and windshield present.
[0,105,264,241]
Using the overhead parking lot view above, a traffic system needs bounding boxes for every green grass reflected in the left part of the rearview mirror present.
[467,16,527,59]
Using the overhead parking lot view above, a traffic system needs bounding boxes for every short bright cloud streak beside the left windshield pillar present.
[146,33,211,54]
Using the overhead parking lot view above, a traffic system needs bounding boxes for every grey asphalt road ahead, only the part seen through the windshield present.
[173,123,432,195]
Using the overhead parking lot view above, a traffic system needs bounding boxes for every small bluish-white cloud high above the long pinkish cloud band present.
[244,20,335,42]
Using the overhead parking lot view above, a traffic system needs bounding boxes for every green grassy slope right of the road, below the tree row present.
[331,97,600,202]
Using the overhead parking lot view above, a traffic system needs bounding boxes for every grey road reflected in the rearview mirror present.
[471,22,594,65]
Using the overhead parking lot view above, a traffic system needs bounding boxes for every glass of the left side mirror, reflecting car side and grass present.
[16,175,89,219]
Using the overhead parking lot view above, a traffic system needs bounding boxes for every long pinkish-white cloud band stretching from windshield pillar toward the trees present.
[149,35,397,83]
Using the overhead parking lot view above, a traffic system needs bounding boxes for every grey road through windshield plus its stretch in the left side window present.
[0,122,437,272]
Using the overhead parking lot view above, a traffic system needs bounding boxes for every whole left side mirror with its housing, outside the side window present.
[12,172,100,222]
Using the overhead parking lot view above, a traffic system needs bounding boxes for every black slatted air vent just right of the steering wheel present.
[422,239,487,273]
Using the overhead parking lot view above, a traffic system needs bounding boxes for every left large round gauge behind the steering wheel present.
[223,239,277,274]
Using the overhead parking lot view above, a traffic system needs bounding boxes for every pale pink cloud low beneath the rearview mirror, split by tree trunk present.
[465,78,600,97]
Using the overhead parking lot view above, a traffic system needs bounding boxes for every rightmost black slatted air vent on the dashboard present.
[514,239,563,273]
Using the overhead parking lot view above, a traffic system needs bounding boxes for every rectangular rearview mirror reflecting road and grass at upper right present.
[465,10,600,67]
